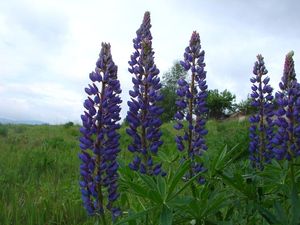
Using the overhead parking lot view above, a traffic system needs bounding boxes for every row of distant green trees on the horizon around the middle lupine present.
[160,61,255,122]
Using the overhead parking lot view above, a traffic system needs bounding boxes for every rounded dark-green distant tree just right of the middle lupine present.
[207,89,235,119]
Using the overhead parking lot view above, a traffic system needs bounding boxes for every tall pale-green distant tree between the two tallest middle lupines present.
[160,61,187,122]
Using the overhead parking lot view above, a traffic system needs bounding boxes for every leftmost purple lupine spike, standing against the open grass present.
[79,43,122,218]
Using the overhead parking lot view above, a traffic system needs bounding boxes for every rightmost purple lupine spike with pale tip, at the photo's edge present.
[273,51,300,160]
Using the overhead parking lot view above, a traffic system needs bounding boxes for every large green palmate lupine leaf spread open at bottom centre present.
[117,160,201,224]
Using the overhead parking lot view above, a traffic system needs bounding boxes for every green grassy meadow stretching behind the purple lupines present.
[0,118,248,225]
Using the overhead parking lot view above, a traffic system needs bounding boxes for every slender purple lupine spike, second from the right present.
[249,55,274,169]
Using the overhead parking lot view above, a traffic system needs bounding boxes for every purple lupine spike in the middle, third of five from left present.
[174,31,208,182]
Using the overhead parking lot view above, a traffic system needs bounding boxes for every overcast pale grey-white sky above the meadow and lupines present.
[0,0,300,124]
